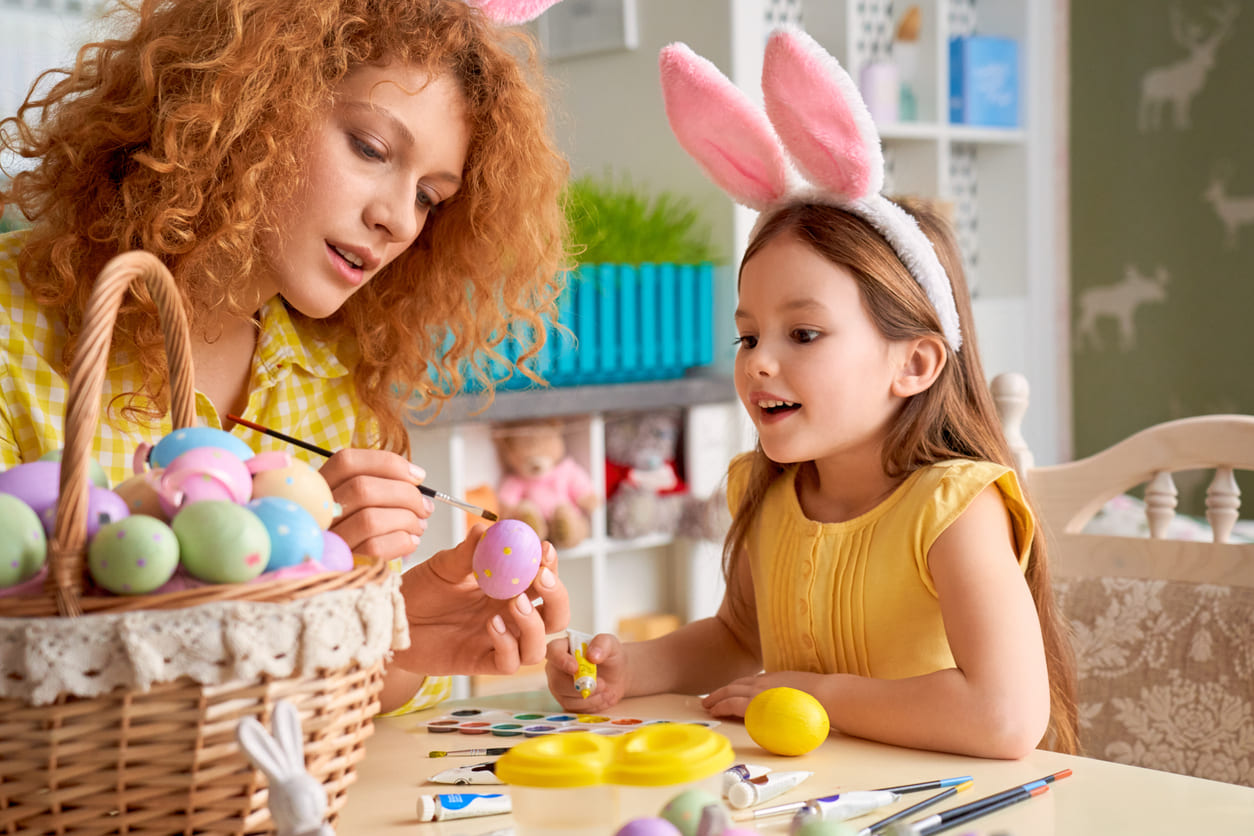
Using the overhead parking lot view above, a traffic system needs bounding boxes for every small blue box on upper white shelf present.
[949,35,1020,128]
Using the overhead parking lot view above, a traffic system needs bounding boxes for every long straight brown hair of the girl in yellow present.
[724,202,1077,753]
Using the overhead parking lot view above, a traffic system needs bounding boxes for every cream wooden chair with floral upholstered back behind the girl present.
[992,374,1254,786]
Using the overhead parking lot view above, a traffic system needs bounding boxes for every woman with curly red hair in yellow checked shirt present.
[0,0,567,706]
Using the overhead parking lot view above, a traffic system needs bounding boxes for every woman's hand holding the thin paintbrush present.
[319,449,435,560]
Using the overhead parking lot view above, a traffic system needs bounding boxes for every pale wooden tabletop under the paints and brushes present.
[336,692,1254,836]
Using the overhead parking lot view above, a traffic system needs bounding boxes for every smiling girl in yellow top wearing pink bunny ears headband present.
[548,31,1075,757]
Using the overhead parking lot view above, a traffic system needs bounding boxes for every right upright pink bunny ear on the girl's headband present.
[762,29,884,201]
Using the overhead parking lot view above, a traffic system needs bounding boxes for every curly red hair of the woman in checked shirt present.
[0,0,567,452]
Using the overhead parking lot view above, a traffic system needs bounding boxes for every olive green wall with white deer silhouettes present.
[1070,0,1254,493]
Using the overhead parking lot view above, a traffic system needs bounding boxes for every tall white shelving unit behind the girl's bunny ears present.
[782,0,1070,461]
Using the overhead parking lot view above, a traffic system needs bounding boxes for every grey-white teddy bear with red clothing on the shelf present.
[606,410,688,540]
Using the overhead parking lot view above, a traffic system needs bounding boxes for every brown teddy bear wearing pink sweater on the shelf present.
[493,419,601,549]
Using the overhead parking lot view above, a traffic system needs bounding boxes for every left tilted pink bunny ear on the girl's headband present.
[658,44,789,211]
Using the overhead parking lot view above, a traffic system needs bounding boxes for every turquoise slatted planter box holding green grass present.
[468,263,714,391]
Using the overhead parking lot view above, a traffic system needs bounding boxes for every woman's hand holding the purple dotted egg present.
[394,523,571,676]
